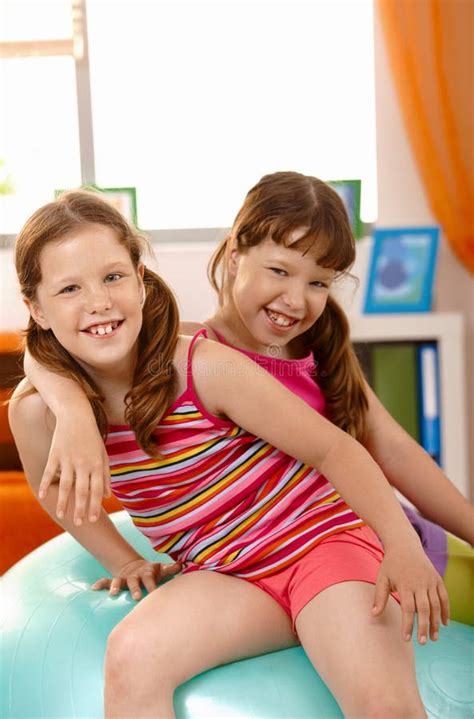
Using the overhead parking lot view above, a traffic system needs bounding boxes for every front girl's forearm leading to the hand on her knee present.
[318,433,419,548]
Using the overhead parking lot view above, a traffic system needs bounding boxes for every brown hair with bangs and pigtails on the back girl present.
[208,172,368,441]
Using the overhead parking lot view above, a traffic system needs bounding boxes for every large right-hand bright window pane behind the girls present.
[88,0,376,228]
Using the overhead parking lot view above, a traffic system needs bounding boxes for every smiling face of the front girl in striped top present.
[26,224,144,377]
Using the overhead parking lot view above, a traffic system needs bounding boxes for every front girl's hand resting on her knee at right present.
[372,545,449,644]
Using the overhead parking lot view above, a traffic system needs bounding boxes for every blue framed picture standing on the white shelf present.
[364,227,439,313]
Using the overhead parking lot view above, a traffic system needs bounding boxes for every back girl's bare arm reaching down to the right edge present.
[364,385,474,545]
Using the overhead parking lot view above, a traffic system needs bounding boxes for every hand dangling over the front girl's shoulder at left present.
[39,415,111,526]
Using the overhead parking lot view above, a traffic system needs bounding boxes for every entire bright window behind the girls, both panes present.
[0,0,376,236]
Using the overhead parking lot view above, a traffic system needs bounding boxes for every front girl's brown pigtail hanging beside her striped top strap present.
[125,268,179,457]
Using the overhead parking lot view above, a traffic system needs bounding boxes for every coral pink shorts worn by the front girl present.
[247,526,398,629]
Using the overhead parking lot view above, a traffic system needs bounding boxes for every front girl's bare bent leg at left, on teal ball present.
[105,571,298,719]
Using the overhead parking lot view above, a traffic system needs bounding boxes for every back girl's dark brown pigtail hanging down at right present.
[305,296,369,442]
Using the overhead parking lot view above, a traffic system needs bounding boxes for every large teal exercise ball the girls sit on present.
[0,512,474,719]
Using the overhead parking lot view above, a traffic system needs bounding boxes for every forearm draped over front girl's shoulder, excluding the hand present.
[23,351,91,421]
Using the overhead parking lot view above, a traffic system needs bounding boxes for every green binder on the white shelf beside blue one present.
[371,342,420,442]
